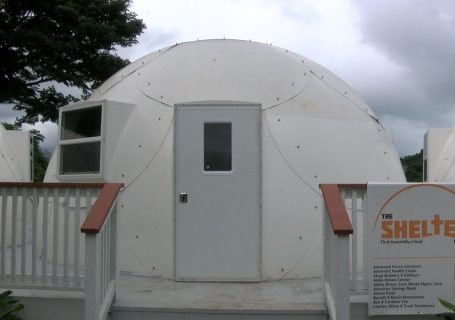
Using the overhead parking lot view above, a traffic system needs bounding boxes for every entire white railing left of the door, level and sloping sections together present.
[0,182,122,320]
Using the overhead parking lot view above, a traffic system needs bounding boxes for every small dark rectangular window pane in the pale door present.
[204,123,232,171]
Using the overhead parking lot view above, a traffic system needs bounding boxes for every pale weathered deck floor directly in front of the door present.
[114,275,326,313]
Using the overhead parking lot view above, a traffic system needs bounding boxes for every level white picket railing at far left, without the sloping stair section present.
[0,183,103,289]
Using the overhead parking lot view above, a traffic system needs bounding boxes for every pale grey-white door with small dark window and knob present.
[175,104,261,281]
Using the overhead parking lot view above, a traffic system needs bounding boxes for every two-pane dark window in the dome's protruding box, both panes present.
[59,105,103,175]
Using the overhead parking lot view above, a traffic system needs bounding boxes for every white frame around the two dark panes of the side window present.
[56,100,106,180]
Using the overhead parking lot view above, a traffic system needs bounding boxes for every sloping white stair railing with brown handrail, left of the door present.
[81,184,122,320]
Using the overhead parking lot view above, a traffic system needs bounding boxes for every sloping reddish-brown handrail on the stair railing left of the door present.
[81,183,123,234]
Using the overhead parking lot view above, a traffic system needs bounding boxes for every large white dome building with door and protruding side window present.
[46,40,405,281]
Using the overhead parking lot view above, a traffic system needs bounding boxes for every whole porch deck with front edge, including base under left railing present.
[4,274,327,320]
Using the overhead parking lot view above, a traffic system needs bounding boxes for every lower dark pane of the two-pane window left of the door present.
[60,141,101,174]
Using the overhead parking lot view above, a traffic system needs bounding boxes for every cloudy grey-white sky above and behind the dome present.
[0,0,455,156]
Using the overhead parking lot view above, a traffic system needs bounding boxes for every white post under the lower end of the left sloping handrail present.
[84,233,101,320]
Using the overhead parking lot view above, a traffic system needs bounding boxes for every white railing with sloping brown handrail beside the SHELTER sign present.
[321,184,368,320]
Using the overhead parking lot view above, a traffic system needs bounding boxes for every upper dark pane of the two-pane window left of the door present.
[61,106,101,140]
